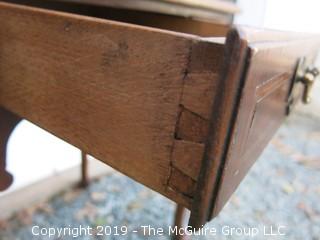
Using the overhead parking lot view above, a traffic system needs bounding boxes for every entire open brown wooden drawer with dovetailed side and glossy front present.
[0,1,320,227]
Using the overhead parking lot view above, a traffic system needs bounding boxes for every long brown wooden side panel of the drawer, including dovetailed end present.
[0,3,223,208]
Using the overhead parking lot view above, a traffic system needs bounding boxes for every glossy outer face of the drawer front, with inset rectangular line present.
[213,32,320,215]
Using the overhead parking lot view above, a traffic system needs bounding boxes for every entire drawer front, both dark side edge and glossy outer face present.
[191,29,320,226]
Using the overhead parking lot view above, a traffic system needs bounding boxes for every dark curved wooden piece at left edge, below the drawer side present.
[0,107,22,191]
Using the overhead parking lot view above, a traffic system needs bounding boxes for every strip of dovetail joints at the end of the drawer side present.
[168,39,224,201]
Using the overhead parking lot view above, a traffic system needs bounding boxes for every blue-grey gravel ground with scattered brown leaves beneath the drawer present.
[0,109,320,240]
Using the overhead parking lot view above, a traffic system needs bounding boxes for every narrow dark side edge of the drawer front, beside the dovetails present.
[189,29,247,228]
